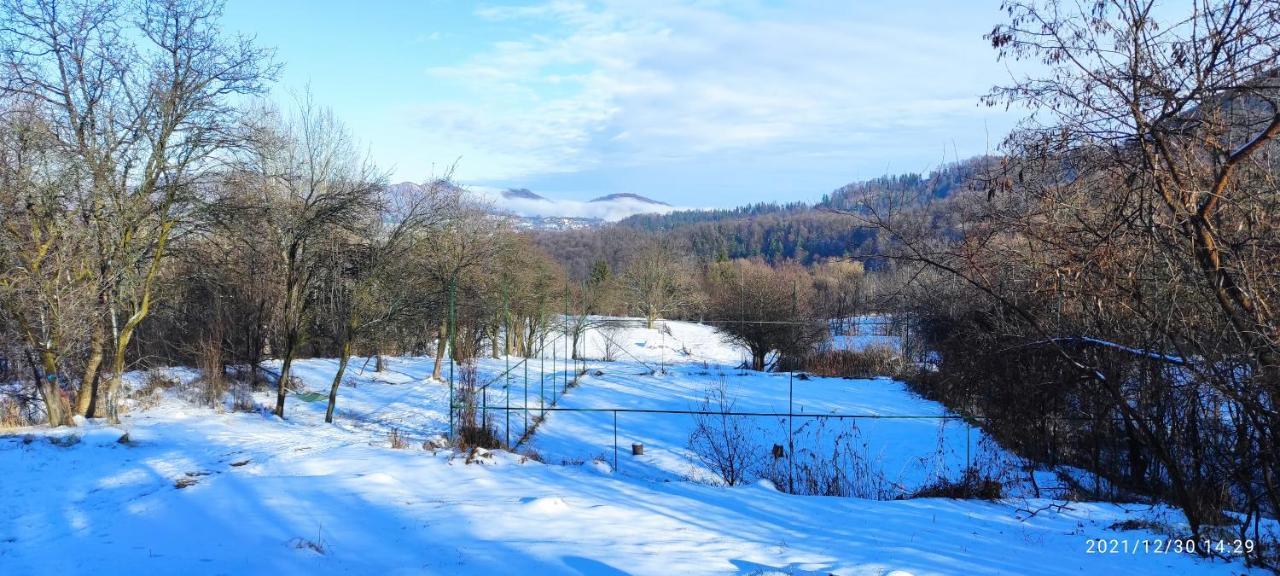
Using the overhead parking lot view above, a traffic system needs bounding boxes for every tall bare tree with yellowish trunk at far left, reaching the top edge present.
[0,0,274,420]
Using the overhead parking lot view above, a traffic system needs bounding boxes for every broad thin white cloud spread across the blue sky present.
[416,0,1013,188]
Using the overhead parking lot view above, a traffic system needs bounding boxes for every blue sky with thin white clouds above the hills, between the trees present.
[224,0,1016,207]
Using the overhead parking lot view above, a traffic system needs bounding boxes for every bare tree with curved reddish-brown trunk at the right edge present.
[989,1,1280,540]
